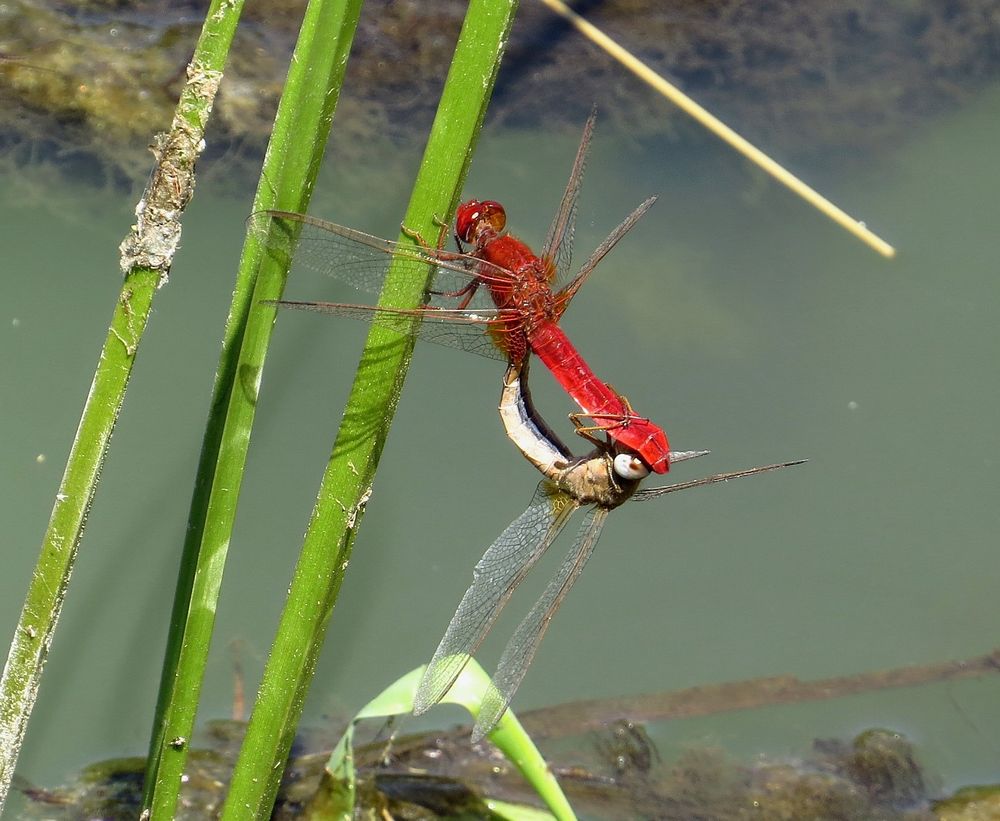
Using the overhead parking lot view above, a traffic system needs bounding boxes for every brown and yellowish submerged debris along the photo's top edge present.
[0,0,1000,184]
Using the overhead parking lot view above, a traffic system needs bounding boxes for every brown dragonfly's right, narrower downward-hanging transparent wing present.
[472,507,608,743]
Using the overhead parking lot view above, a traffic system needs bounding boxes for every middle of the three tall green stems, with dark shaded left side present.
[144,0,361,819]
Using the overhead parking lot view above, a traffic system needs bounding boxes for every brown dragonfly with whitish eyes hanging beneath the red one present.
[413,356,802,742]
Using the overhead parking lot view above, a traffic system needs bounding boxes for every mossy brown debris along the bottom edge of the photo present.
[13,721,984,821]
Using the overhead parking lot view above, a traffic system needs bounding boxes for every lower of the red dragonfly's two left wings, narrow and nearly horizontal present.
[265,300,521,361]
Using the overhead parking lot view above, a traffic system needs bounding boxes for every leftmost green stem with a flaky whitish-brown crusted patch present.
[0,0,243,812]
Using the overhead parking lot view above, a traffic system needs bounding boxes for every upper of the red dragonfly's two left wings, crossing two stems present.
[248,211,511,308]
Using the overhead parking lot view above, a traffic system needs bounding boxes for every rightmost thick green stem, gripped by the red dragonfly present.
[223,0,517,819]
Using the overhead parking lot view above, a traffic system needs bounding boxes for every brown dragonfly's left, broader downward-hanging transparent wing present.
[413,481,579,715]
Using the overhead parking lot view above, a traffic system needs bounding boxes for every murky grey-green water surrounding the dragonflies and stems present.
[0,75,1000,800]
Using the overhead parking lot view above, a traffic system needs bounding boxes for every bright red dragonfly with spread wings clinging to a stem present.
[260,114,670,473]
